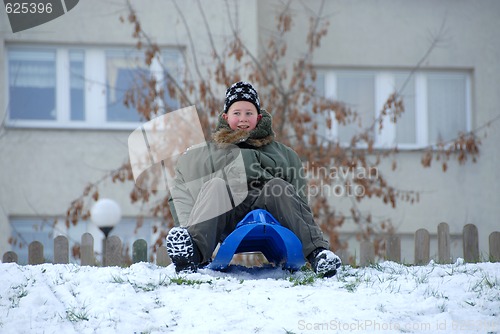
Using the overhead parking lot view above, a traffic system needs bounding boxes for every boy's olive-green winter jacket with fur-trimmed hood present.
[169,110,307,225]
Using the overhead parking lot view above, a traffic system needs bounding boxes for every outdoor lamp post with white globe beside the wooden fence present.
[90,198,122,265]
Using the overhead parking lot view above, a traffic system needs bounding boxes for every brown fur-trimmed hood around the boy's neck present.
[212,109,274,147]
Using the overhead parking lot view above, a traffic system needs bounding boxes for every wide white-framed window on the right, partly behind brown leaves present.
[316,70,471,149]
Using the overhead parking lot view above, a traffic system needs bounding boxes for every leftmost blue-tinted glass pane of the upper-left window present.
[7,50,57,120]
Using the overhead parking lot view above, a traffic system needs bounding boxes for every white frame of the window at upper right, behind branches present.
[320,68,472,150]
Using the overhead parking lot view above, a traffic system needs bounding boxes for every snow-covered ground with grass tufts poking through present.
[0,259,500,334]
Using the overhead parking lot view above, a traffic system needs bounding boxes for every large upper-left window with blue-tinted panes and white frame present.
[7,46,183,129]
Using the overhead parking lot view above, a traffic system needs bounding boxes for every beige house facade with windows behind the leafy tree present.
[0,0,500,263]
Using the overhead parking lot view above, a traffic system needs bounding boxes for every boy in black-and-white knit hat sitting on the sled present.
[166,82,341,277]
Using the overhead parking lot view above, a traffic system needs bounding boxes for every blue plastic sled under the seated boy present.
[207,209,305,271]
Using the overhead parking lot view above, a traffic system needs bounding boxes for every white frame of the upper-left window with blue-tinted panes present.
[4,44,184,130]
